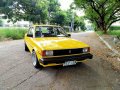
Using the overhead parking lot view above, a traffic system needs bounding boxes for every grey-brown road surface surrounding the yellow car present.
[0,32,120,90]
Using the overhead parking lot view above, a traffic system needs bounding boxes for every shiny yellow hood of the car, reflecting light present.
[33,37,89,50]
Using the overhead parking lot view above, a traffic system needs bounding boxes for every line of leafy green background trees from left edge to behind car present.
[0,0,85,29]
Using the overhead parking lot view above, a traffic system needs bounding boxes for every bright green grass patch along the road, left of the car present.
[0,28,27,40]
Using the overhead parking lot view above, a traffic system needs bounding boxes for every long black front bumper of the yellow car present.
[40,53,93,65]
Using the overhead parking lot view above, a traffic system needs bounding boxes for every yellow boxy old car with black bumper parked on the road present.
[24,25,93,68]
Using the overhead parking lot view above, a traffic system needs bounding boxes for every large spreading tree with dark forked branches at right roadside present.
[74,0,120,34]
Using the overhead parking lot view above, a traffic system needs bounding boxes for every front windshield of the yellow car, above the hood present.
[35,26,67,37]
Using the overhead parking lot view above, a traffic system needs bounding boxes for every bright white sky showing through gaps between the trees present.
[58,0,84,16]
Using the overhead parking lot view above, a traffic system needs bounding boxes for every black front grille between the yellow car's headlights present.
[53,48,83,56]
